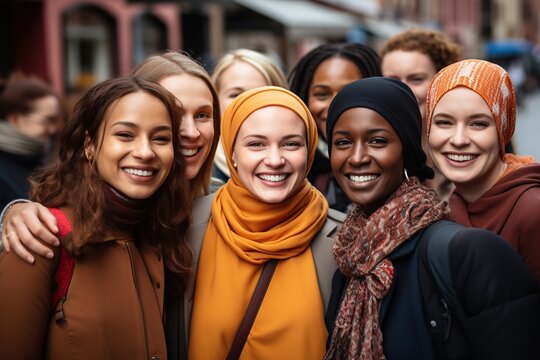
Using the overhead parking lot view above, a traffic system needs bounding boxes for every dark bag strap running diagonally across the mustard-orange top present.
[227,259,278,360]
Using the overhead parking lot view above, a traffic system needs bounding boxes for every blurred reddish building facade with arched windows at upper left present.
[0,0,181,94]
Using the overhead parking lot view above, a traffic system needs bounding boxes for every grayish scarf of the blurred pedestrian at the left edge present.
[0,121,47,156]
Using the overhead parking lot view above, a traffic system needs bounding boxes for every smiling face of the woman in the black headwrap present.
[330,108,404,214]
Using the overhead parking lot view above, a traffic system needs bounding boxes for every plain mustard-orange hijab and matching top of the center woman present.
[189,86,328,359]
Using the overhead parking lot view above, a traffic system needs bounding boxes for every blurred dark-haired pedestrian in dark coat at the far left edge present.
[0,74,60,208]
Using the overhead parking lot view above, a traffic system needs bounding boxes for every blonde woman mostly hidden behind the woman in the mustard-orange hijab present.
[212,49,288,182]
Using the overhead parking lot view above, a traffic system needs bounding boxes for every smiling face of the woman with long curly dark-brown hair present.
[85,92,174,199]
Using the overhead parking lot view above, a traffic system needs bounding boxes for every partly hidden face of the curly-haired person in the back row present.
[381,50,437,116]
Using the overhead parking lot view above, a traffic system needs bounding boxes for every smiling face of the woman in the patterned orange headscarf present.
[429,87,505,202]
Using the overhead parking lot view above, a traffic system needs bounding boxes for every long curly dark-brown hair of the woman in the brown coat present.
[31,77,192,292]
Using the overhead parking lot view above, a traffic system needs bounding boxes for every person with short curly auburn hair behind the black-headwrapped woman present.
[381,29,462,199]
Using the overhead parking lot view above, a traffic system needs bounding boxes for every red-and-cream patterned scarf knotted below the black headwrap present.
[325,177,448,360]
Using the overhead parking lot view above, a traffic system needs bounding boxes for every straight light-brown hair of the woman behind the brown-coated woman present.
[132,51,220,199]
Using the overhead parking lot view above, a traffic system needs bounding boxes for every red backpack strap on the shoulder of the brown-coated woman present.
[49,208,75,323]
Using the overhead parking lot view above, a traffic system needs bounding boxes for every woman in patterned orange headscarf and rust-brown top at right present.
[425,59,540,281]
